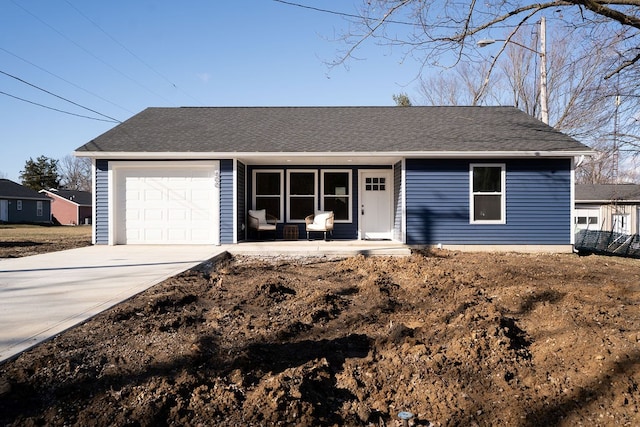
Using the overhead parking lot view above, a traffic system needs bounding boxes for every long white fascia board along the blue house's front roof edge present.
[73,150,595,160]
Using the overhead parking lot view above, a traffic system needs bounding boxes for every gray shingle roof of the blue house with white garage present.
[77,107,590,153]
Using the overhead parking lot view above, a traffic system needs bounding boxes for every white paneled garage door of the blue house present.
[116,165,219,244]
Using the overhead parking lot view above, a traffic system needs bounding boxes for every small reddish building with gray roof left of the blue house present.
[40,188,92,225]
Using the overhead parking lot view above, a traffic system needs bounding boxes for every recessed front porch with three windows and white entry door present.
[240,164,402,243]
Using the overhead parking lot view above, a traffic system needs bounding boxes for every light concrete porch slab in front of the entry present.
[225,240,411,256]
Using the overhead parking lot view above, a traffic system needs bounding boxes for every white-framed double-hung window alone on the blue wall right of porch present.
[469,164,506,224]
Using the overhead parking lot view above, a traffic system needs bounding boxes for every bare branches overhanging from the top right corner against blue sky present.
[337,0,640,77]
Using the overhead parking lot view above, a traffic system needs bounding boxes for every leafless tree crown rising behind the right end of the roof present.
[408,11,640,183]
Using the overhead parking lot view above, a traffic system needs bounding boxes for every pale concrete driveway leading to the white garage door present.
[0,245,225,362]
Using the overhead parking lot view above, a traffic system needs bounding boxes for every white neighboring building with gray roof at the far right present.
[574,184,640,235]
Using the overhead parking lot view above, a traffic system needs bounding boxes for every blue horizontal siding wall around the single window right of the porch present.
[406,159,571,245]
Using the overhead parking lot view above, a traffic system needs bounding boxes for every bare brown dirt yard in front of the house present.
[0,232,640,426]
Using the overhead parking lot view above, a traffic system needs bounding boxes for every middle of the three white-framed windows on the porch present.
[287,170,318,222]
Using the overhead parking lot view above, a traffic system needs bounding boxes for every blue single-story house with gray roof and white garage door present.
[75,107,592,251]
